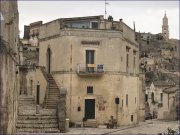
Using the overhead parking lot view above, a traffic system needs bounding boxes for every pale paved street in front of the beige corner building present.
[66,120,179,134]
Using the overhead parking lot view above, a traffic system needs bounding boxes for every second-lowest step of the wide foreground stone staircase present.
[16,123,58,129]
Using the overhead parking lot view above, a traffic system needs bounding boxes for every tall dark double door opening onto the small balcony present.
[86,50,95,72]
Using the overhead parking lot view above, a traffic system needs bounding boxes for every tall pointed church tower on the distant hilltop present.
[162,12,169,40]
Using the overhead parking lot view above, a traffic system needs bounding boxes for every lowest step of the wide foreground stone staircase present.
[17,128,60,133]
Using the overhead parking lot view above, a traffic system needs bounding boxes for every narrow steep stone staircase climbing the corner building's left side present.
[46,74,60,109]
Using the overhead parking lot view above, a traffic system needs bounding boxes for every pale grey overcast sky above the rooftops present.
[18,1,179,39]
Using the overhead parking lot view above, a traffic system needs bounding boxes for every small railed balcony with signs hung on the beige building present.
[77,64,104,76]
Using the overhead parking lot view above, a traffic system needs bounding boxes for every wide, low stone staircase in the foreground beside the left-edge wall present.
[16,95,60,133]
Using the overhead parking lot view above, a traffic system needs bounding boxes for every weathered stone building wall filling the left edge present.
[0,0,19,134]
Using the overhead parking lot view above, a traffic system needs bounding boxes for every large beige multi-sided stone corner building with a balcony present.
[28,16,144,125]
